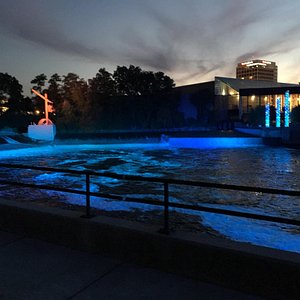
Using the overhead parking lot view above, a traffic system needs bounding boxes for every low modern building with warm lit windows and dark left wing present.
[174,77,300,126]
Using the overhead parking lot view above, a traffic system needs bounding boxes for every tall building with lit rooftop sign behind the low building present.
[236,59,277,82]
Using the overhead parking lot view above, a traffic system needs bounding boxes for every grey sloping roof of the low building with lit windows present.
[215,77,300,91]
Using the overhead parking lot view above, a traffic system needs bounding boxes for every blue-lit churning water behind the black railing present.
[0,144,300,252]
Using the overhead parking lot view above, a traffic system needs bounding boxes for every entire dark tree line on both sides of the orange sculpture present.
[0,65,183,131]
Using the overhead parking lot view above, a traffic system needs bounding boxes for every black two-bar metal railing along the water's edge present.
[0,163,300,233]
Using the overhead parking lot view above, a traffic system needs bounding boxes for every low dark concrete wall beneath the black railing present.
[0,199,300,299]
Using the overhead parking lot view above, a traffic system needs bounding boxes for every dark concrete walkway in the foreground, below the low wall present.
[0,231,258,300]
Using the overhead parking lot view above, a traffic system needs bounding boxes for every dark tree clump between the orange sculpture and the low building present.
[27,65,175,130]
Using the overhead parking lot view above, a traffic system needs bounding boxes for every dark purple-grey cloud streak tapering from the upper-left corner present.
[0,1,107,61]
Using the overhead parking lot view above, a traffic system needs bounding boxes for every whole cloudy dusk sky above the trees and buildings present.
[0,0,300,95]
